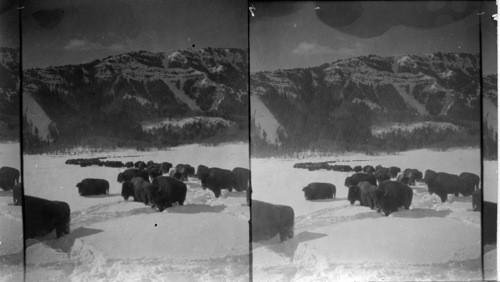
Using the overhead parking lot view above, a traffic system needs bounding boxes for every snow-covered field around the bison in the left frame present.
[24,143,250,281]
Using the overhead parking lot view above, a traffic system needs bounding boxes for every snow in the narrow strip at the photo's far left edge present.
[0,143,23,281]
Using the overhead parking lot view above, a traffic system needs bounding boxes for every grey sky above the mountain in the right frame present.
[250,1,497,73]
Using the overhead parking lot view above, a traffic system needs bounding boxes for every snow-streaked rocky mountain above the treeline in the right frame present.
[254,53,484,144]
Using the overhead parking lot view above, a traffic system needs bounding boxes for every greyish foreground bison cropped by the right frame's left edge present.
[252,200,295,242]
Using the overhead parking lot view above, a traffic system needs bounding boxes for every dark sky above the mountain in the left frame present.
[22,0,248,68]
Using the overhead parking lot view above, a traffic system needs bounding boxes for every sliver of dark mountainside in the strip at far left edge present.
[0,47,20,141]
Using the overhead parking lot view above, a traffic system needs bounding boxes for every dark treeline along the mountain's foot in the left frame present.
[23,115,248,154]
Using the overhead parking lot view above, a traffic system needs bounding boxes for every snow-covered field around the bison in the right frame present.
[251,149,490,281]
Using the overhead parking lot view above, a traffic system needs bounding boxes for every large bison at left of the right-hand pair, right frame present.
[427,172,463,203]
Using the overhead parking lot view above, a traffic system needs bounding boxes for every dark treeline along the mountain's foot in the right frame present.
[251,111,482,157]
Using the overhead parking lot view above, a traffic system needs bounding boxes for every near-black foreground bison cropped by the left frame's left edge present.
[23,196,70,239]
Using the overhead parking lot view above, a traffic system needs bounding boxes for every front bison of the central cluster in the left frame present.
[146,176,187,212]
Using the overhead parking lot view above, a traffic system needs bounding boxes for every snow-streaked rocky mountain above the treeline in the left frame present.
[23,48,248,143]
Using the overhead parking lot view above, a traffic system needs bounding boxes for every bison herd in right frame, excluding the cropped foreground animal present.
[300,162,482,215]
